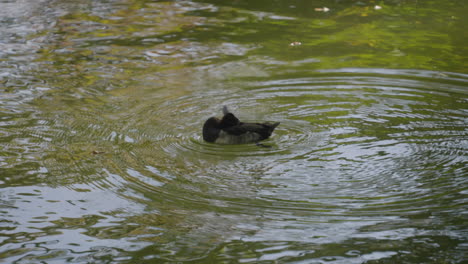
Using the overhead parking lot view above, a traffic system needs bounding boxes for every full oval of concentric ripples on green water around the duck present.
[32,69,468,221]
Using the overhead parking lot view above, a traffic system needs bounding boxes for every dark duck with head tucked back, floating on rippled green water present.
[203,106,280,146]
